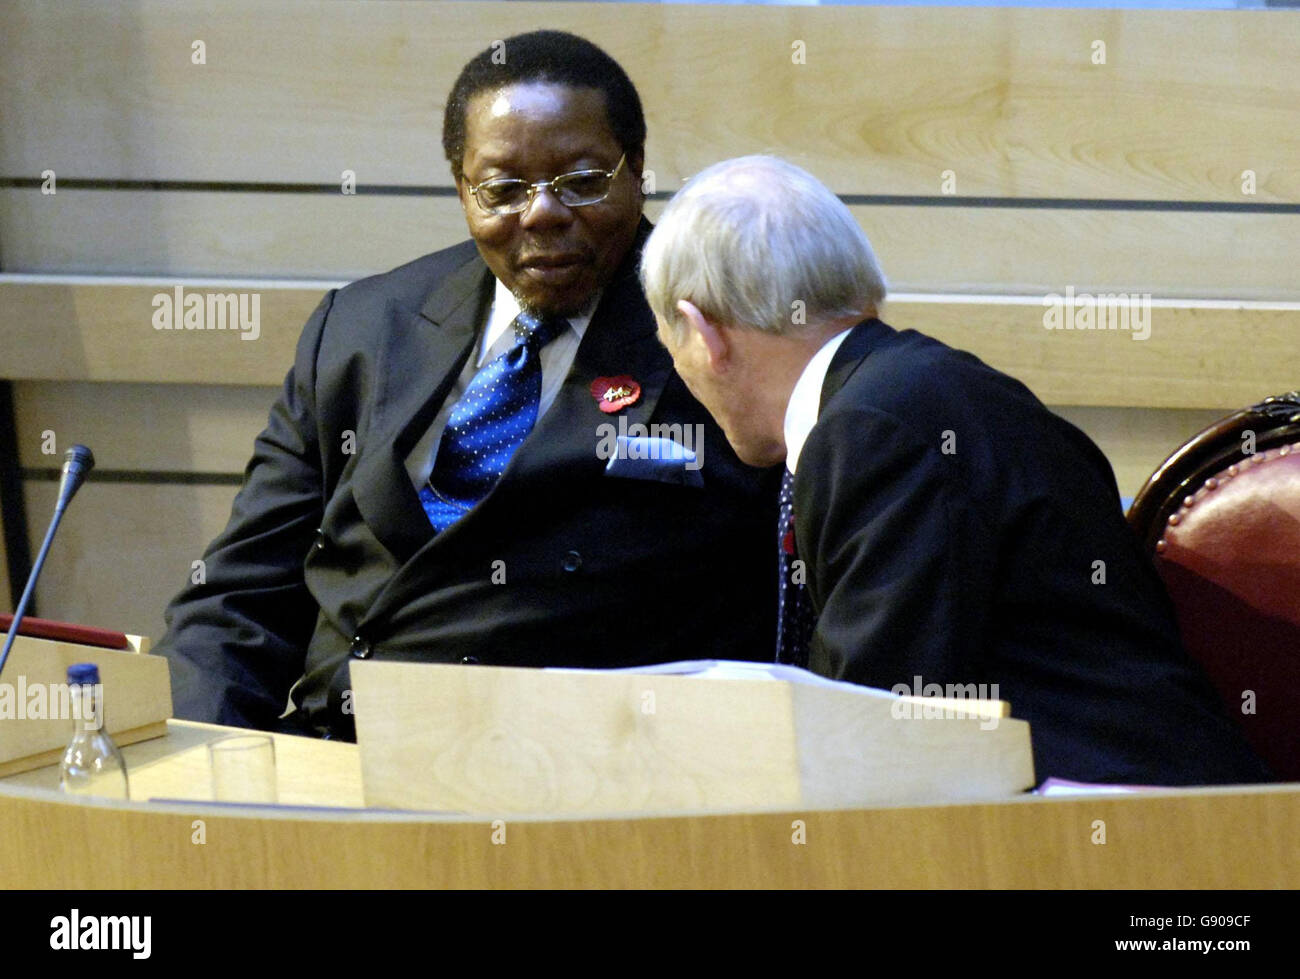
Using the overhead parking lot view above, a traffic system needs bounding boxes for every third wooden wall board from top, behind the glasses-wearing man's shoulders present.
[0,280,1300,408]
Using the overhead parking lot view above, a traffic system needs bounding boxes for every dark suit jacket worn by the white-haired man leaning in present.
[794,320,1268,785]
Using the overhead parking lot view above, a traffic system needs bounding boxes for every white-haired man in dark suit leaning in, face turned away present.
[641,156,1269,785]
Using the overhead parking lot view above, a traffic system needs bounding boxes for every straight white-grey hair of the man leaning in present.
[641,156,885,338]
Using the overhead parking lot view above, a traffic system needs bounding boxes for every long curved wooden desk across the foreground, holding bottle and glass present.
[0,720,1300,888]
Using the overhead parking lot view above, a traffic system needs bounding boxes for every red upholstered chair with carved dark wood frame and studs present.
[1128,391,1300,781]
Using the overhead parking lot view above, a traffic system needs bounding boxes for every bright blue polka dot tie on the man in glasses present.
[420,312,568,532]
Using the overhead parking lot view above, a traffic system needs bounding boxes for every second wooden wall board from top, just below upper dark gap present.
[0,189,1300,300]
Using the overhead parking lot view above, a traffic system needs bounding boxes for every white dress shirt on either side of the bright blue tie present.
[406,280,601,490]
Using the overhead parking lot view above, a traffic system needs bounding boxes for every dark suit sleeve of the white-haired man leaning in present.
[794,408,992,689]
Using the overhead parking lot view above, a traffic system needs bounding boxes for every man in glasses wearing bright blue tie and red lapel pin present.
[161,31,779,738]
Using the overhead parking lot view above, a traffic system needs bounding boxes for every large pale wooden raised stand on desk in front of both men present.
[351,662,1035,814]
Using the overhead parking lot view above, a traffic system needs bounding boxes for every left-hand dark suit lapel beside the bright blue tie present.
[352,254,493,560]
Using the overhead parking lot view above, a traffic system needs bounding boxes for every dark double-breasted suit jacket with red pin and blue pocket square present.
[160,221,779,737]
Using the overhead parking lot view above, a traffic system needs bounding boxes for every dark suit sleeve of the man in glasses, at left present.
[155,291,334,729]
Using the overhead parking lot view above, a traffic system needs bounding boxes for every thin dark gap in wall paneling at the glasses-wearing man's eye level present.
[0,177,1300,215]
